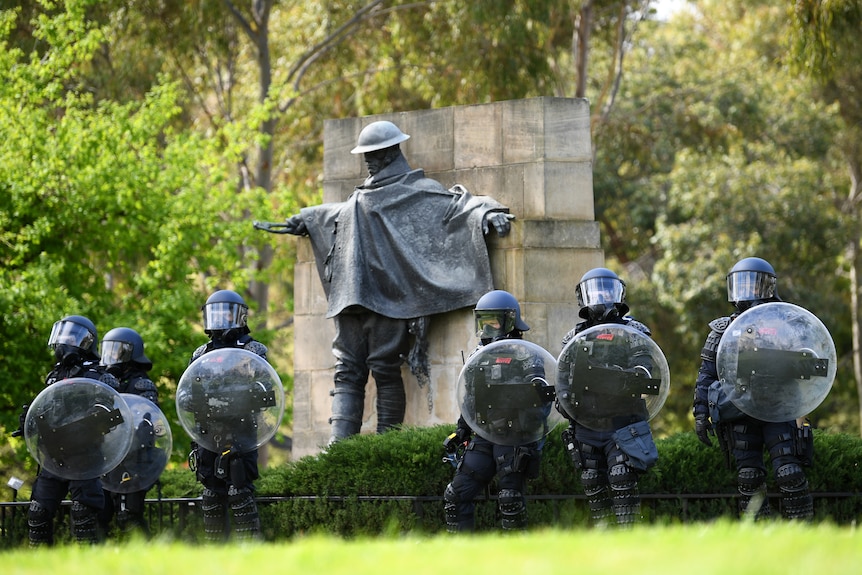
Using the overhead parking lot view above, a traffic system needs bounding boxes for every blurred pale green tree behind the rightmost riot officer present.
[594,2,856,430]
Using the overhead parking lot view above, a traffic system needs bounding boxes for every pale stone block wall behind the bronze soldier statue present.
[292,98,604,459]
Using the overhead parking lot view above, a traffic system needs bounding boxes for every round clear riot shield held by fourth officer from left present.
[457,339,562,445]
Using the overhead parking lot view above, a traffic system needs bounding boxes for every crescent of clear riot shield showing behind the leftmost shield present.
[102,393,173,493]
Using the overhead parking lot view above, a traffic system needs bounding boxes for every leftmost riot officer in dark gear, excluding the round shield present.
[22,315,120,546]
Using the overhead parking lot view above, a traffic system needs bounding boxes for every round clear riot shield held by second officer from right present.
[556,324,670,431]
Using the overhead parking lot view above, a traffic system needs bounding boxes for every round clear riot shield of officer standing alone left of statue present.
[176,348,284,453]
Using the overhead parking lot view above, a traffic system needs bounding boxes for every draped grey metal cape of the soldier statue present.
[300,167,508,319]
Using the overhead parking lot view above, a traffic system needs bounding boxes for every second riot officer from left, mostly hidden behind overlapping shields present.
[99,327,159,537]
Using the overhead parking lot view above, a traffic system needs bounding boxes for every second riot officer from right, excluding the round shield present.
[557,268,658,527]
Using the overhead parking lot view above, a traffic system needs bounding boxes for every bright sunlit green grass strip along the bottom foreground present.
[0,521,862,575]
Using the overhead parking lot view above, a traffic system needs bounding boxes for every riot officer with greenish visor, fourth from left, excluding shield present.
[443,290,550,533]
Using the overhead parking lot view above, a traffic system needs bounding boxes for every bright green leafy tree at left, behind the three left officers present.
[0,2,270,460]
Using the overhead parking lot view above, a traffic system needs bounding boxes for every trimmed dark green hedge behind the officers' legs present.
[155,426,862,540]
